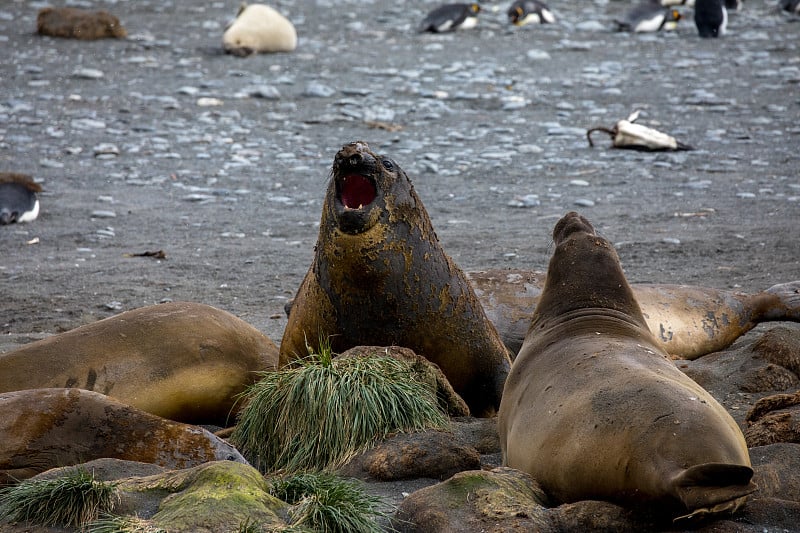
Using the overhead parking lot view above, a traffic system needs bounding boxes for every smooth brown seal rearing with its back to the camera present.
[498,212,756,518]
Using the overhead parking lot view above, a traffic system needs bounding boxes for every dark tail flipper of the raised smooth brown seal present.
[673,463,758,522]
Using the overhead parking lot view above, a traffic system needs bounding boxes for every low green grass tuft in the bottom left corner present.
[0,468,116,528]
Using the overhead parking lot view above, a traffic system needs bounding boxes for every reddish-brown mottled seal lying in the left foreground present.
[0,388,247,485]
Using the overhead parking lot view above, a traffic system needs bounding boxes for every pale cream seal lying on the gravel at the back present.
[222,3,297,56]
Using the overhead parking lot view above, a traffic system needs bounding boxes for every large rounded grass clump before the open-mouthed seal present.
[231,350,448,473]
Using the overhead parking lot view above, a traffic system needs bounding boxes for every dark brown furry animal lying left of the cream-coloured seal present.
[36,7,128,41]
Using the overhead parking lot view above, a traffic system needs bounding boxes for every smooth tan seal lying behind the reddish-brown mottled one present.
[0,302,278,426]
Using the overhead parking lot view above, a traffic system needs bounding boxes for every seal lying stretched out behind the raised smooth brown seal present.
[467,269,800,359]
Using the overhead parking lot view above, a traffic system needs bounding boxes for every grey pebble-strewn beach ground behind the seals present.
[0,0,800,528]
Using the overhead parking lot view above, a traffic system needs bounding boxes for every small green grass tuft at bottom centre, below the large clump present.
[270,472,388,533]
